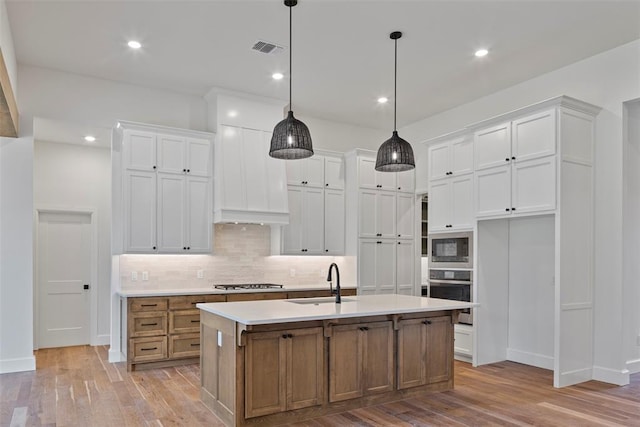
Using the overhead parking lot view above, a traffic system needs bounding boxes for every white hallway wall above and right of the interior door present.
[33,140,111,344]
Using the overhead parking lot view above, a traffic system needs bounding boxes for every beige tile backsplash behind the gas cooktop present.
[119,224,356,290]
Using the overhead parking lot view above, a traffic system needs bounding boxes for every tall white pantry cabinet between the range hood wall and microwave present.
[345,150,420,295]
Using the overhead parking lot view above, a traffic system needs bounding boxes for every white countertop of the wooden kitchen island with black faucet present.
[196,294,477,325]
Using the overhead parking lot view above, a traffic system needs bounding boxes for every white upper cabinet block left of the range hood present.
[112,122,213,254]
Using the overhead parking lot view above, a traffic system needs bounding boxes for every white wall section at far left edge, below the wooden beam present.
[0,137,35,373]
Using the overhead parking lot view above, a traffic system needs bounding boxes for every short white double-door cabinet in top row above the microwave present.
[429,137,473,181]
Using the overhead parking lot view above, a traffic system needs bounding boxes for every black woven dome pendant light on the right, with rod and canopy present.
[376,31,416,172]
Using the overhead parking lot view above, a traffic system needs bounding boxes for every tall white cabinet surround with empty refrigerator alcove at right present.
[429,96,600,387]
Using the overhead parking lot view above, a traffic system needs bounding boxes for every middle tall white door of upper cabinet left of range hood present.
[157,173,187,253]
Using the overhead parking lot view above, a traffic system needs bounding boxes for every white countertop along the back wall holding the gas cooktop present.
[117,282,356,298]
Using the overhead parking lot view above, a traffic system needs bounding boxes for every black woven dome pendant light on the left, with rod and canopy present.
[269,0,313,160]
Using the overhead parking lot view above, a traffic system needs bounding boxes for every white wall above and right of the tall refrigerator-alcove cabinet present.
[401,40,640,378]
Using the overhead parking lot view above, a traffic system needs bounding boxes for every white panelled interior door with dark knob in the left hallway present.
[37,213,92,348]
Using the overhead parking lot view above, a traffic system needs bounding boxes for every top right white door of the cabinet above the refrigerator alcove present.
[511,109,556,162]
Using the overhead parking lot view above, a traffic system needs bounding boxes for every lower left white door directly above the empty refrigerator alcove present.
[478,164,511,217]
